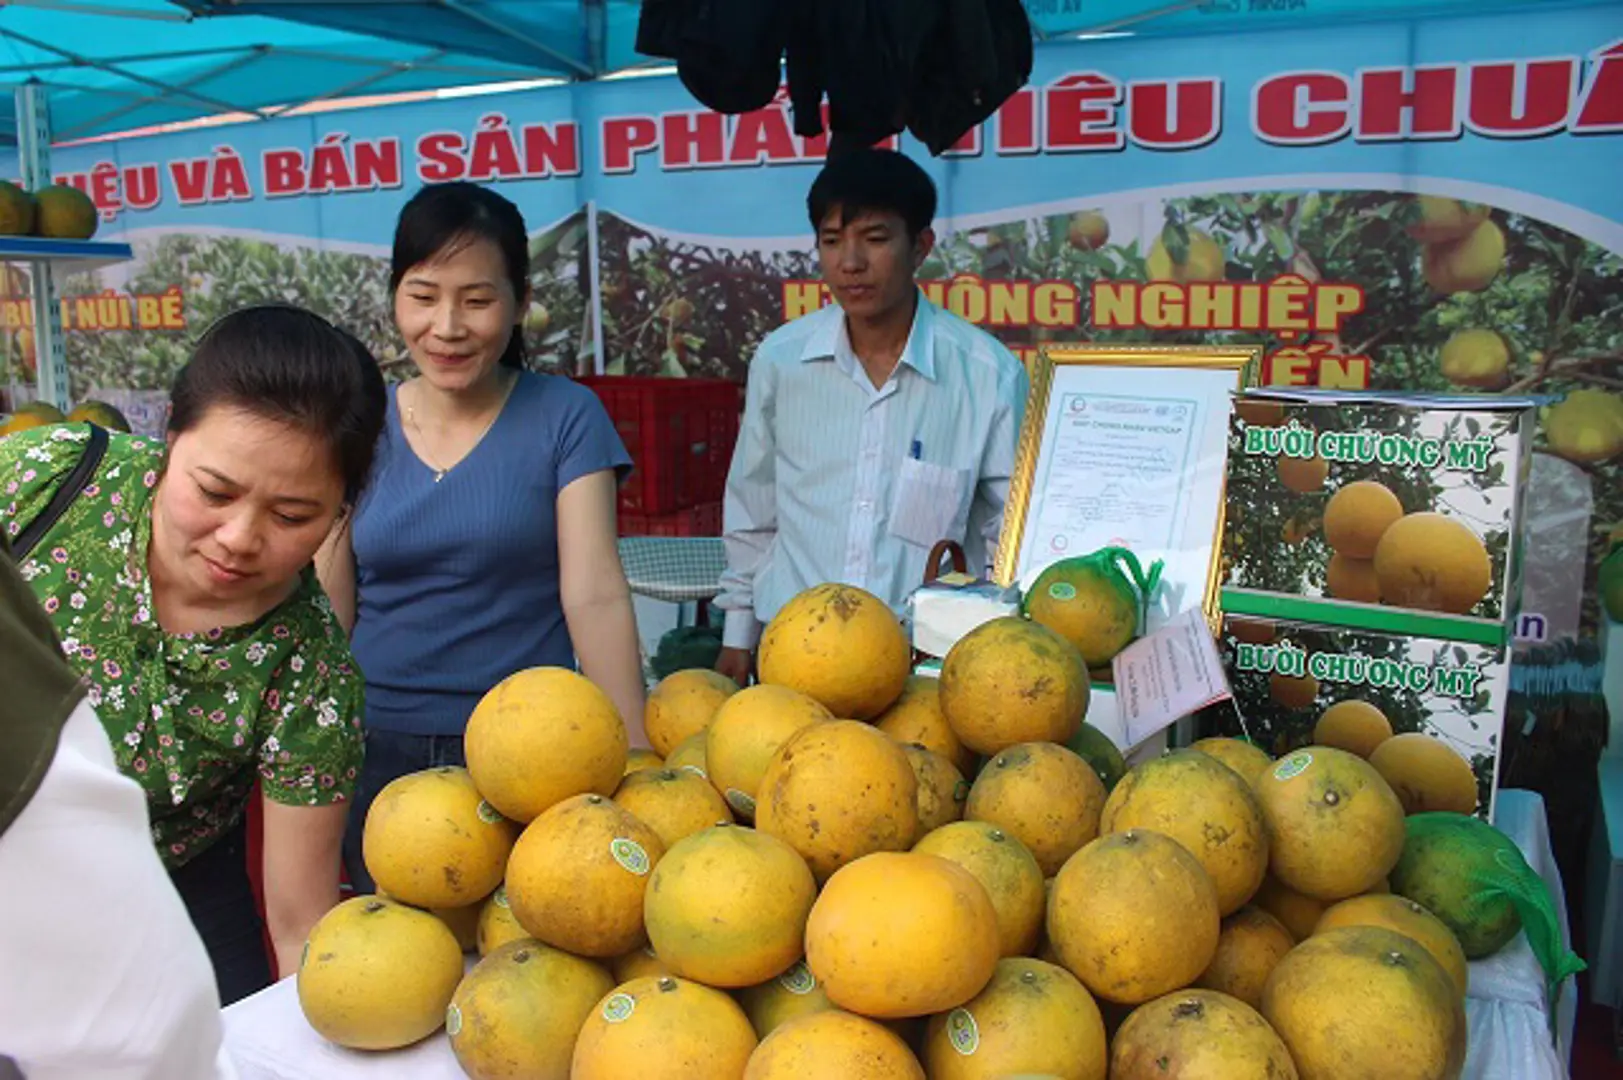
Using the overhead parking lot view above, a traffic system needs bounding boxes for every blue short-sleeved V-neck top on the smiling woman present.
[352,374,631,734]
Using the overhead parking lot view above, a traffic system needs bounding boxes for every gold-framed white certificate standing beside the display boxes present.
[993,344,1263,630]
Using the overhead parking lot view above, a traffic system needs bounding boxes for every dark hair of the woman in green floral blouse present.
[169,304,388,507]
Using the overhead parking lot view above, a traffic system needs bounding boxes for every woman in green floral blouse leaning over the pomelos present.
[0,307,385,1002]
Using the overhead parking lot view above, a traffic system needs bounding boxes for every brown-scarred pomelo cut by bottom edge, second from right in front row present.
[1110,989,1298,1080]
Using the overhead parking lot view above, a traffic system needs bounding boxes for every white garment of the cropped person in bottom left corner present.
[0,702,237,1080]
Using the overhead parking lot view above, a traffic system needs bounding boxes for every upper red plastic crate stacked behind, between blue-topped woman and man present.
[579,375,740,516]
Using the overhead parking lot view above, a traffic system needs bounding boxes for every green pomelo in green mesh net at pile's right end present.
[1391,812,1584,1015]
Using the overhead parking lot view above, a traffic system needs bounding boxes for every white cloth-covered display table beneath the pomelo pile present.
[224,791,1578,1080]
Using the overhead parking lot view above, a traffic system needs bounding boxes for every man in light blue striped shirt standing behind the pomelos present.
[716,149,1027,684]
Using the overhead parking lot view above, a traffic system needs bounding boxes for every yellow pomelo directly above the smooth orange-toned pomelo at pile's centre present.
[755,719,919,882]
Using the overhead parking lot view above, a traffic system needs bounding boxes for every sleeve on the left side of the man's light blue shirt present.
[714,357,777,648]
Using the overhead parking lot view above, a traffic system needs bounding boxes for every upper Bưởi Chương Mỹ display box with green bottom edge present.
[1222,390,1539,646]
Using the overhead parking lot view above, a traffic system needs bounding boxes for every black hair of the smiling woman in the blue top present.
[390,180,529,370]
